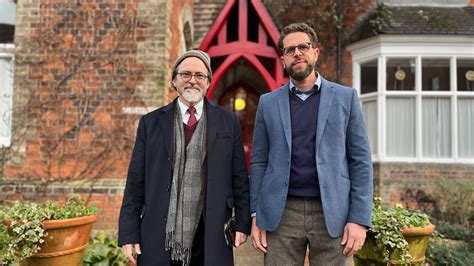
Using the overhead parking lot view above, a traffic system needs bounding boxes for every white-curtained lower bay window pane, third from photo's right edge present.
[387,98,415,157]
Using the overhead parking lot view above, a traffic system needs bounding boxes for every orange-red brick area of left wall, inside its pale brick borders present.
[4,1,147,183]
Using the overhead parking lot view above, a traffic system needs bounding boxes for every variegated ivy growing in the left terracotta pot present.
[0,197,98,261]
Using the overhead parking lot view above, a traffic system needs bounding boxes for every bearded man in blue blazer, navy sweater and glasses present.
[250,23,373,265]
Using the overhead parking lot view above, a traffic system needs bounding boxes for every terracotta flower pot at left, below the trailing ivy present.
[20,215,97,266]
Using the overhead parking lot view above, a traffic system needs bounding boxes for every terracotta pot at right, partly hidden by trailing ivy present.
[354,224,434,266]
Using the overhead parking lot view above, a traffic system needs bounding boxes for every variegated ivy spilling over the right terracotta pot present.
[369,197,430,262]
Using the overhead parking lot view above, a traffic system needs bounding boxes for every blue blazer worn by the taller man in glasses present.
[250,79,373,237]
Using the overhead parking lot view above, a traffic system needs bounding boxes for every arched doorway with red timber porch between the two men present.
[199,0,287,168]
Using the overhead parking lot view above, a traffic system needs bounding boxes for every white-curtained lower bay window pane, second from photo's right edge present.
[421,97,451,158]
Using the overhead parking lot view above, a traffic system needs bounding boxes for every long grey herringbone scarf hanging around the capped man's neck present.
[165,104,206,266]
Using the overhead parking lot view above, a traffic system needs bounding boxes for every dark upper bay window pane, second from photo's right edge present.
[421,59,450,91]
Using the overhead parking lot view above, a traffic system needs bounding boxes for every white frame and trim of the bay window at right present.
[347,35,474,164]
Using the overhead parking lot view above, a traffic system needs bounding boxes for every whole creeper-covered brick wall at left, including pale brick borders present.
[0,0,181,230]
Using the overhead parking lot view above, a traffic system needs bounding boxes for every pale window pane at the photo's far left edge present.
[0,57,13,146]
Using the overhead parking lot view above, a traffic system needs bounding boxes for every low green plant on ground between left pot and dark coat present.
[84,231,127,266]
